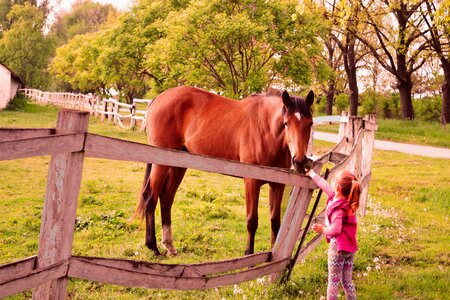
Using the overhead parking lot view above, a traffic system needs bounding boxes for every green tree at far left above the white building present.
[0,3,53,88]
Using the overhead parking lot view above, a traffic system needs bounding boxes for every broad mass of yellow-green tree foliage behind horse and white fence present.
[50,0,327,102]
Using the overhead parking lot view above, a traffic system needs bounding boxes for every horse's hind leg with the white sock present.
[160,167,186,255]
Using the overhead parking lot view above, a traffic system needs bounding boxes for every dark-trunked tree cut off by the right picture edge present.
[422,0,450,125]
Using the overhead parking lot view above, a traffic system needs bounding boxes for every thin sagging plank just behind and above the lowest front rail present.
[73,252,271,277]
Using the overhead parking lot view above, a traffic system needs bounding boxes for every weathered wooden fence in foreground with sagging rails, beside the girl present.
[0,110,376,299]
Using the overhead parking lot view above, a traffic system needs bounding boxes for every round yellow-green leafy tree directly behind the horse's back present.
[149,0,321,98]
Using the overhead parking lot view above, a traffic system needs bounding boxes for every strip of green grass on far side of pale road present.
[315,119,450,148]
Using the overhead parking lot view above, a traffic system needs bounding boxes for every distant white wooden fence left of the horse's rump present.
[19,89,151,131]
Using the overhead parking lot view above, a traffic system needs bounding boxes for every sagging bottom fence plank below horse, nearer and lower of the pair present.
[68,258,288,290]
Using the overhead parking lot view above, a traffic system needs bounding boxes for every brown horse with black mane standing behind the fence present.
[136,87,314,255]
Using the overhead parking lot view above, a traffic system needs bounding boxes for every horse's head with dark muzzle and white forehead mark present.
[281,91,314,174]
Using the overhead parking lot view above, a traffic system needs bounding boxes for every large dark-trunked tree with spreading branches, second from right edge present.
[358,0,427,120]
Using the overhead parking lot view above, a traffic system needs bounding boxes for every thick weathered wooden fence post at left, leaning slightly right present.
[33,110,89,300]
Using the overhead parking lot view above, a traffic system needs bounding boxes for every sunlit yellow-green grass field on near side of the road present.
[0,104,450,299]
